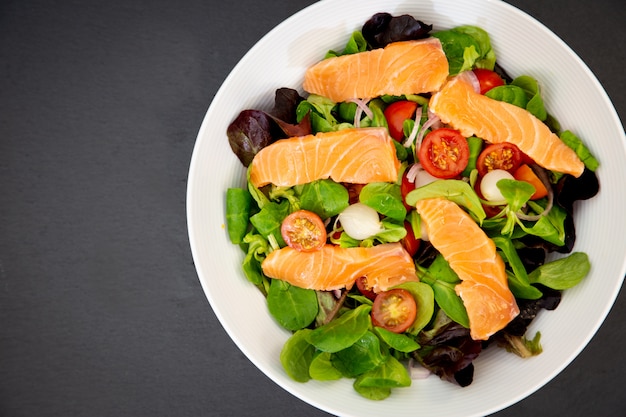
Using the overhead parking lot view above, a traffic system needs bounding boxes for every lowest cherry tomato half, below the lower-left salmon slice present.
[371,288,417,333]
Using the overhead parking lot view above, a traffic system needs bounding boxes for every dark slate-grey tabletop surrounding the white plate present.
[0,0,626,417]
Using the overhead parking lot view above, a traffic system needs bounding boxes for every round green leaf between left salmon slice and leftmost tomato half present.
[300,179,350,219]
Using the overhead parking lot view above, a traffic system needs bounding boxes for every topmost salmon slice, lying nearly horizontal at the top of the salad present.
[303,38,448,102]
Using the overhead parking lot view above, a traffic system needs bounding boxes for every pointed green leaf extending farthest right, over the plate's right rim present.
[528,252,591,290]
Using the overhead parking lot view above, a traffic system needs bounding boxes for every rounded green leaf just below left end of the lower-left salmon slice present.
[267,279,319,330]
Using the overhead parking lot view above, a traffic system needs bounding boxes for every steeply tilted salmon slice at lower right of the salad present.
[416,198,519,340]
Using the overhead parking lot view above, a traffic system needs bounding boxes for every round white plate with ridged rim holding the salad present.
[187,0,626,417]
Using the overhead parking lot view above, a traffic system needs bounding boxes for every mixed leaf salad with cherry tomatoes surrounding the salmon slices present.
[226,13,599,400]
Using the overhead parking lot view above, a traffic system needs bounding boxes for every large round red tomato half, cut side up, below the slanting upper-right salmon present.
[418,127,469,179]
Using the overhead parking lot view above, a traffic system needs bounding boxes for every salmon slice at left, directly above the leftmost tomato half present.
[250,127,400,187]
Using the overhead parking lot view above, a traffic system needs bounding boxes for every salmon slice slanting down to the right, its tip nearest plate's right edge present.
[430,73,585,177]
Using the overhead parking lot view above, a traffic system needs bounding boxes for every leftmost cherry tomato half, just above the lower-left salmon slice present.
[280,210,326,252]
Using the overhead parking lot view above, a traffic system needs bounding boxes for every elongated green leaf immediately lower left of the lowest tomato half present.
[307,304,372,353]
